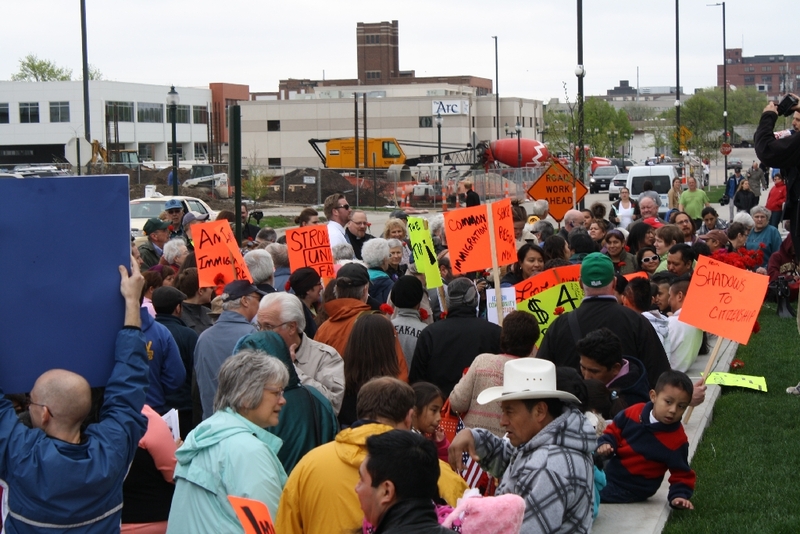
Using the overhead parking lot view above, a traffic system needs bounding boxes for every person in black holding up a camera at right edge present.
[754,94,800,261]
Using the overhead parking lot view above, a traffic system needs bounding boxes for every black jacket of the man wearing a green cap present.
[536,297,670,388]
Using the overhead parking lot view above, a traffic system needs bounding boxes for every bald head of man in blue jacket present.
[31,369,92,437]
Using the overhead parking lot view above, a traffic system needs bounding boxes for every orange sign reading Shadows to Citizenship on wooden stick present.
[679,256,769,345]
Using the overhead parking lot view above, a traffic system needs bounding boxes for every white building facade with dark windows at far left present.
[0,81,211,165]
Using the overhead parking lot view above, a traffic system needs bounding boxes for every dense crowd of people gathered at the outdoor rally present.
[0,116,796,534]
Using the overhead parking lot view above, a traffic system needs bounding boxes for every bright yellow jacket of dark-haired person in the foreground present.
[275,423,467,534]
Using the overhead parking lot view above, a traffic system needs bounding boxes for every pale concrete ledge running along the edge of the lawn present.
[592,336,739,534]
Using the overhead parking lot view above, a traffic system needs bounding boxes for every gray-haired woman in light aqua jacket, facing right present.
[167,349,289,534]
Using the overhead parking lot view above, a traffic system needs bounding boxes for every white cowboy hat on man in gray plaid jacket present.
[477,358,580,404]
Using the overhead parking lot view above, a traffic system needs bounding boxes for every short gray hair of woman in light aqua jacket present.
[214,349,289,413]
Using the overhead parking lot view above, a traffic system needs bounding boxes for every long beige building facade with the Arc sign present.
[240,84,543,167]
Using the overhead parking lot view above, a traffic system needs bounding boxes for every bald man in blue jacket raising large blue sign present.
[0,262,148,534]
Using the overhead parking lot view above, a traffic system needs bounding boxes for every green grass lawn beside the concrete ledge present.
[664,303,800,534]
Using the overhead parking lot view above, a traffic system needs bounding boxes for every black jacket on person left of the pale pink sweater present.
[408,306,500,397]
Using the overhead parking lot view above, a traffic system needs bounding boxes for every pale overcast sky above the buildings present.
[0,0,800,101]
